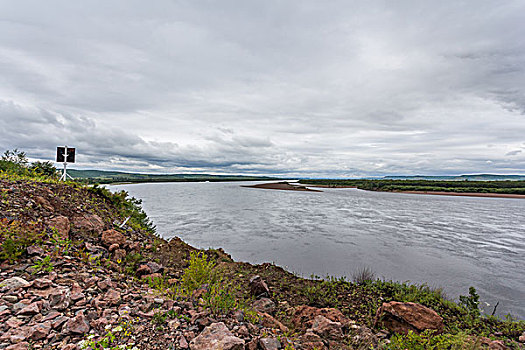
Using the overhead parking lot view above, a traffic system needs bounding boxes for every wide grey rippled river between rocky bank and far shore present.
[110,182,525,319]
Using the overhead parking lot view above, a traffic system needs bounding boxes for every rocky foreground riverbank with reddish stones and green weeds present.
[0,179,525,350]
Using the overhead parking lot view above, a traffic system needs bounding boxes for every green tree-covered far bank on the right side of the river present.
[300,179,525,194]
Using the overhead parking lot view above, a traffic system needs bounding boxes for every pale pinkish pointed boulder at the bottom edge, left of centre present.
[190,322,244,350]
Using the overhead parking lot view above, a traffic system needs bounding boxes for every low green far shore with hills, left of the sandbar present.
[67,169,275,184]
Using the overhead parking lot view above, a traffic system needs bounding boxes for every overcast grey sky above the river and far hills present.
[0,0,525,177]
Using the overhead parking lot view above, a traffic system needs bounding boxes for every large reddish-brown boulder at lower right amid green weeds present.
[375,301,443,334]
